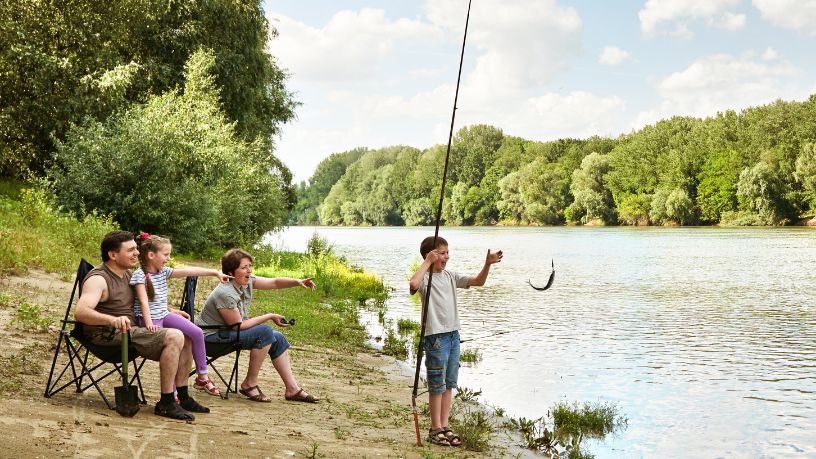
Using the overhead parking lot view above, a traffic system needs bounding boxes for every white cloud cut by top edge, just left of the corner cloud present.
[638,0,745,39]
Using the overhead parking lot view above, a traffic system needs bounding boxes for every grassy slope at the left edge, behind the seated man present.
[0,181,116,279]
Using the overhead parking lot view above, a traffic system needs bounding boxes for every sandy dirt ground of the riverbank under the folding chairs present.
[0,271,506,458]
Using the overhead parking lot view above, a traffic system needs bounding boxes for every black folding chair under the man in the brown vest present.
[44,259,147,409]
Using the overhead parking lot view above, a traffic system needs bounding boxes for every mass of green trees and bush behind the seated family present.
[0,0,298,250]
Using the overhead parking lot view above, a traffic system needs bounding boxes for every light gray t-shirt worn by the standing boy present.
[419,269,470,336]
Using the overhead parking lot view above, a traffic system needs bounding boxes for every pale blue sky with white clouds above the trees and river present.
[263,0,816,181]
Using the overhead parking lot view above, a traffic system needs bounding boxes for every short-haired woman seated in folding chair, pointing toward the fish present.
[196,249,318,403]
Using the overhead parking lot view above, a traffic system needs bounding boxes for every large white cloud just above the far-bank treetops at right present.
[632,50,807,128]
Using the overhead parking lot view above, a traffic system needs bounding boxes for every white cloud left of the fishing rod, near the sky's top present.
[268,9,441,83]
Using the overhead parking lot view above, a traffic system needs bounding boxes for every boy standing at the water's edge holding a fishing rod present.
[408,236,503,446]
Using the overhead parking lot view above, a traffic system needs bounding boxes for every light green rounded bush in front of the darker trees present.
[49,51,289,252]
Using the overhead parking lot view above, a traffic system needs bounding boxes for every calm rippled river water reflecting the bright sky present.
[269,227,816,458]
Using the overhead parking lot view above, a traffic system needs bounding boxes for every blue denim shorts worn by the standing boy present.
[423,330,459,395]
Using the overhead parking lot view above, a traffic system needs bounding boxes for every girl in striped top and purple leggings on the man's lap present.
[130,233,232,395]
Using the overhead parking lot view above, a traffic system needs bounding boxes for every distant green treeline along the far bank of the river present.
[290,95,816,225]
